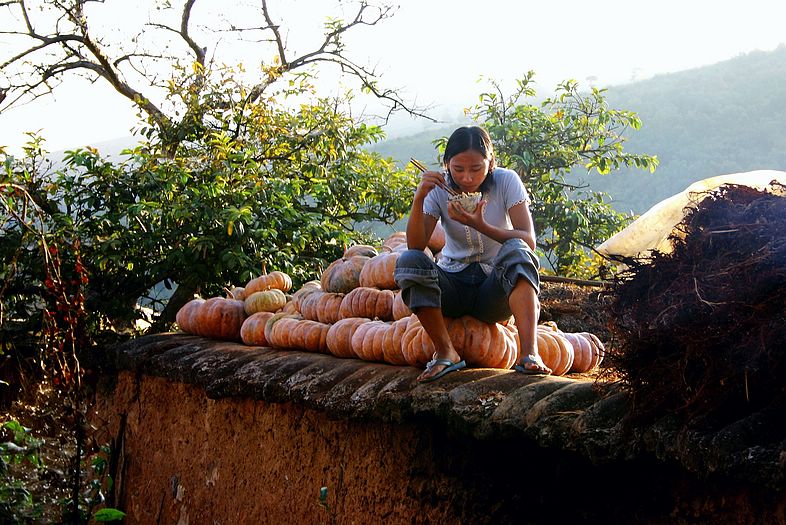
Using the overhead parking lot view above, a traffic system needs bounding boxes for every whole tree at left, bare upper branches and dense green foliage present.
[0,0,422,336]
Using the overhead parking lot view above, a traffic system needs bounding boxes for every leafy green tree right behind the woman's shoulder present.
[470,72,658,277]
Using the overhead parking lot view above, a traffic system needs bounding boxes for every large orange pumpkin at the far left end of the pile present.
[175,297,246,341]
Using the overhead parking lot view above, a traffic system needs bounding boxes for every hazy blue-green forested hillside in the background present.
[373,45,786,214]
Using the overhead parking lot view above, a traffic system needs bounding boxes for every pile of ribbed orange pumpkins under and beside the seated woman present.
[177,228,604,375]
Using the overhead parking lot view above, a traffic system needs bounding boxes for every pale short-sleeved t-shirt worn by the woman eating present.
[423,168,530,273]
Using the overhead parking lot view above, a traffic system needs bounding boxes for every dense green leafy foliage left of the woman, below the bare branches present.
[2,68,414,330]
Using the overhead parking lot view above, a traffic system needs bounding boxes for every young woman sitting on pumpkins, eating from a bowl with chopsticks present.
[395,126,551,382]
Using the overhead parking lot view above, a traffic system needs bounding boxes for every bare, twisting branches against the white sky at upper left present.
[0,0,433,143]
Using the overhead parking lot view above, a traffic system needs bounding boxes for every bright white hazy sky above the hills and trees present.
[0,0,786,151]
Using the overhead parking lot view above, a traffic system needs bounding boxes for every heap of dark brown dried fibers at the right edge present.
[609,182,786,432]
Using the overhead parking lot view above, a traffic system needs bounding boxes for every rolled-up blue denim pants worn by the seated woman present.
[394,239,540,323]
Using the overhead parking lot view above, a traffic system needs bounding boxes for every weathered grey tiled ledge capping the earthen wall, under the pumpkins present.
[108,333,786,491]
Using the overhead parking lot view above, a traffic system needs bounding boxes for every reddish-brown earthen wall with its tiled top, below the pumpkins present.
[93,334,786,524]
